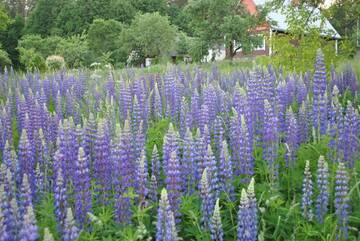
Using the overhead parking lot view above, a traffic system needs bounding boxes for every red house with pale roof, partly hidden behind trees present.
[206,0,341,61]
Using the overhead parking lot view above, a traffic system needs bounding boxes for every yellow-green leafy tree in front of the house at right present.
[258,5,352,73]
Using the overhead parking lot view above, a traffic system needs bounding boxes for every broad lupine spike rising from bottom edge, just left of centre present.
[156,188,179,241]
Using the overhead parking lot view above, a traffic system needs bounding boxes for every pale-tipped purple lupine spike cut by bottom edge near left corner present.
[19,205,39,241]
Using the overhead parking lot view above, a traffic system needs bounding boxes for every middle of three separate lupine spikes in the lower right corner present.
[316,156,329,223]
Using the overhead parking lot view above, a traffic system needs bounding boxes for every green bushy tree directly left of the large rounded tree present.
[88,19,123,62]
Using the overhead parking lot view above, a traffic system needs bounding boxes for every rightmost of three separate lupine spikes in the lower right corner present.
[334,162,350,240]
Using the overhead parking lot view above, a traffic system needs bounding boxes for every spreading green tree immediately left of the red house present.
[185,0,264,59]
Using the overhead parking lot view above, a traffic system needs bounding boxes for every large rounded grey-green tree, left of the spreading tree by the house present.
[127,12,176,57]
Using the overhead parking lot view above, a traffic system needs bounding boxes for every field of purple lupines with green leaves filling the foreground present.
[0,51,360,241]
